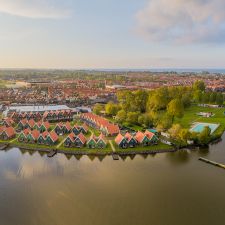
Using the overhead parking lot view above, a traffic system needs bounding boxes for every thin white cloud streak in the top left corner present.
[0,0,70,19]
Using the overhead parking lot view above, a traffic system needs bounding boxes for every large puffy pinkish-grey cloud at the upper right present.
[136,0,225,43]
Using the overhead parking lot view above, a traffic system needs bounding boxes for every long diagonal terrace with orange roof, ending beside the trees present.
[80,113,120,136]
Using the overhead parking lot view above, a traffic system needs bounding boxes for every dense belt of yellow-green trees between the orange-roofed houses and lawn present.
[94,81,224,145]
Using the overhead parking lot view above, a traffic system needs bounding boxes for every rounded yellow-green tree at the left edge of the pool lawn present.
[167,99,184,122]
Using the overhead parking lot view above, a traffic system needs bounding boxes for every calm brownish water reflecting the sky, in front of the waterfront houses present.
[0,136,225,225]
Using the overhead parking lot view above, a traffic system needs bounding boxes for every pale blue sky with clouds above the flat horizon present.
[0,0,225,69]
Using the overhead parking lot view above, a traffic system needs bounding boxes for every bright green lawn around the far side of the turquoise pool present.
[174,106,225,135]
